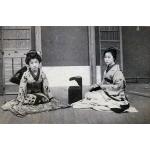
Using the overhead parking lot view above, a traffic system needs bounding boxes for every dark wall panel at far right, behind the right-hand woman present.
[122,26,150,81]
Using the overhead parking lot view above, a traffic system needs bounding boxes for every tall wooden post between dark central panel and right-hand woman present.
[88,26,96,84]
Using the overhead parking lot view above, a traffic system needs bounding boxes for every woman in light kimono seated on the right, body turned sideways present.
[72,48,129,113]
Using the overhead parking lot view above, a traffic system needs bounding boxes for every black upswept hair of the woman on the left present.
[25,50,42,65]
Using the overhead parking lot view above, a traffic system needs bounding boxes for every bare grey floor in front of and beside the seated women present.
[0,94,150,124]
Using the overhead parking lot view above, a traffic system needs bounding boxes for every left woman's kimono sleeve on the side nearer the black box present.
[42,72,53,99]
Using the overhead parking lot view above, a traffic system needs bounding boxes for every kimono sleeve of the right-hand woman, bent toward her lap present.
[102,71,125,91]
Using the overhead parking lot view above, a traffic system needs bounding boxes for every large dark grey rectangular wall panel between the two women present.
[41,26,89,66]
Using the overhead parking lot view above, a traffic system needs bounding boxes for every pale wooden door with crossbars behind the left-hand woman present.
[2,26,31,85]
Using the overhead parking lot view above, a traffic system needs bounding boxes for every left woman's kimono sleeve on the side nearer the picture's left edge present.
[17,72,27,102]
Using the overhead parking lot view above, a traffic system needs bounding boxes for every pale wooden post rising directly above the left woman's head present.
[35,26,42,54]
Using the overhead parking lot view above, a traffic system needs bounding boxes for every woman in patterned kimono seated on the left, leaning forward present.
[2,50,68,116]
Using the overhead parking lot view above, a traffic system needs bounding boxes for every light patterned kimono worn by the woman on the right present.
[72,64,129,110]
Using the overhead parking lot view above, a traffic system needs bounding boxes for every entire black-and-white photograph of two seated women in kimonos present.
[0,26,150,124]
